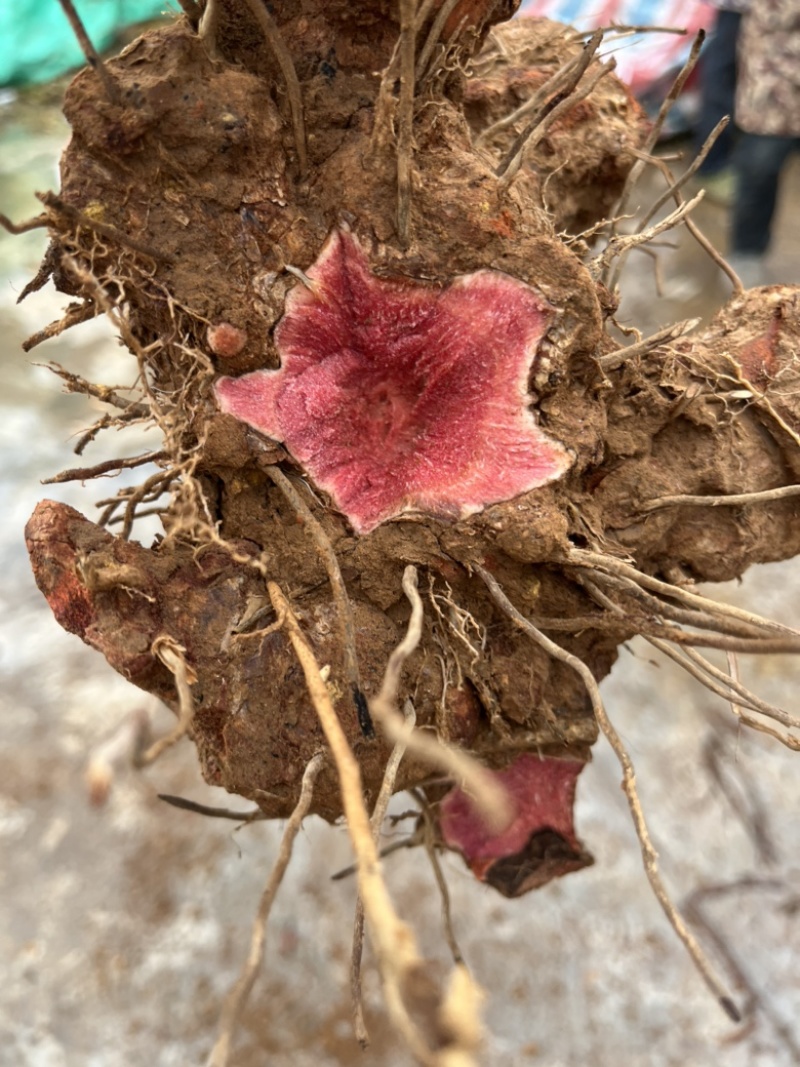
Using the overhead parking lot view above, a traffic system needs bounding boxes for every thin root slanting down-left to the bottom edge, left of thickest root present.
[208,752,325,1067]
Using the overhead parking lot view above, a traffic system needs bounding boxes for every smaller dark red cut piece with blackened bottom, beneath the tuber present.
[439,753,592,896]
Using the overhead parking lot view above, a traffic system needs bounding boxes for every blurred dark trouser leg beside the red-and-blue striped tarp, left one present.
[694,11,741,176]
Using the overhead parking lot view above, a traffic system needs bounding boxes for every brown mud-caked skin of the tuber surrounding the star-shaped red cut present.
[21,0,800,892]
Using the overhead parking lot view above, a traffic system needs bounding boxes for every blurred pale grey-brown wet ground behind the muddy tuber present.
[0,73,800,1067]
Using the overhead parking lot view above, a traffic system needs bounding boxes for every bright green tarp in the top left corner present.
[0,0,178,85]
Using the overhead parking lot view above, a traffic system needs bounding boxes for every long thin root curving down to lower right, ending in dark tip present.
[473,564,740,1022]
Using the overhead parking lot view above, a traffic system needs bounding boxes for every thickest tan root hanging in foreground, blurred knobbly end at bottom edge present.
[267,582,479,1067]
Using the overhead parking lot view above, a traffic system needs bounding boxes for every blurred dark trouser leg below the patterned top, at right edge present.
[731,133,800,256]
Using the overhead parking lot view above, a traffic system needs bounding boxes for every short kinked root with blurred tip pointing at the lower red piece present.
[369,566,513,833]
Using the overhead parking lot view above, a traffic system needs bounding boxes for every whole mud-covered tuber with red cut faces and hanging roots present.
[9,0,800,1067]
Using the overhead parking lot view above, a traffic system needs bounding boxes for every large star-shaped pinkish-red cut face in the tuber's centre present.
[217,230,571,534]
